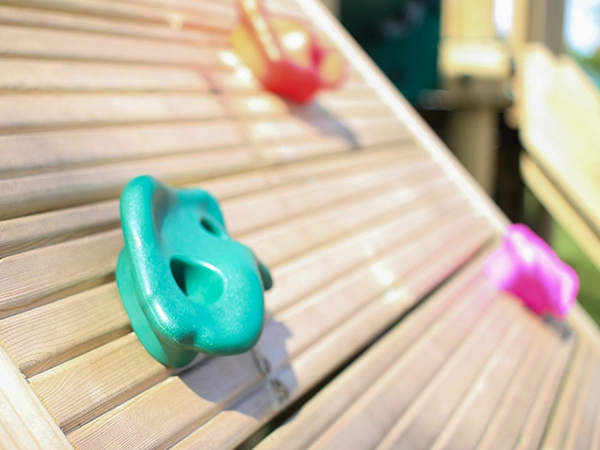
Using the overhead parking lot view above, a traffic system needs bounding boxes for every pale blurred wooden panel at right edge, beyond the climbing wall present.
[519,44,600,236]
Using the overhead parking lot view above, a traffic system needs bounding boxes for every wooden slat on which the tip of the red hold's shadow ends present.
[0,110,407,177]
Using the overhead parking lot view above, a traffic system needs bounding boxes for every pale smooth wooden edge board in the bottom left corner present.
[0,346,72,450]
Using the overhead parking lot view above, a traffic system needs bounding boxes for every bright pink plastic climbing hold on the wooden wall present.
[484,224,579,319]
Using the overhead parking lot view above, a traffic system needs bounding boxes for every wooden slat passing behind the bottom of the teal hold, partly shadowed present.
[30,199,478,430]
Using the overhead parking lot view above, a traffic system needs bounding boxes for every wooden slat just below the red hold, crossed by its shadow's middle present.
[0,93,401,133]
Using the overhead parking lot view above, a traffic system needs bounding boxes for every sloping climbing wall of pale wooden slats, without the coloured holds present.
[0,0,597,449]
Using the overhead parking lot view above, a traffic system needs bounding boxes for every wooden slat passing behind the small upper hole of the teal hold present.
[0,146,420,328]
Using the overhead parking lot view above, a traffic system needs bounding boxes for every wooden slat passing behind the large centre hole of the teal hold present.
[0,151,436,376]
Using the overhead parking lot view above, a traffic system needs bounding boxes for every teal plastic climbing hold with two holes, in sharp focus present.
[116,176,272,367]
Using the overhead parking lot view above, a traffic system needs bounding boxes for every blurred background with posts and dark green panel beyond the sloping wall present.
[324,0,600,323]
